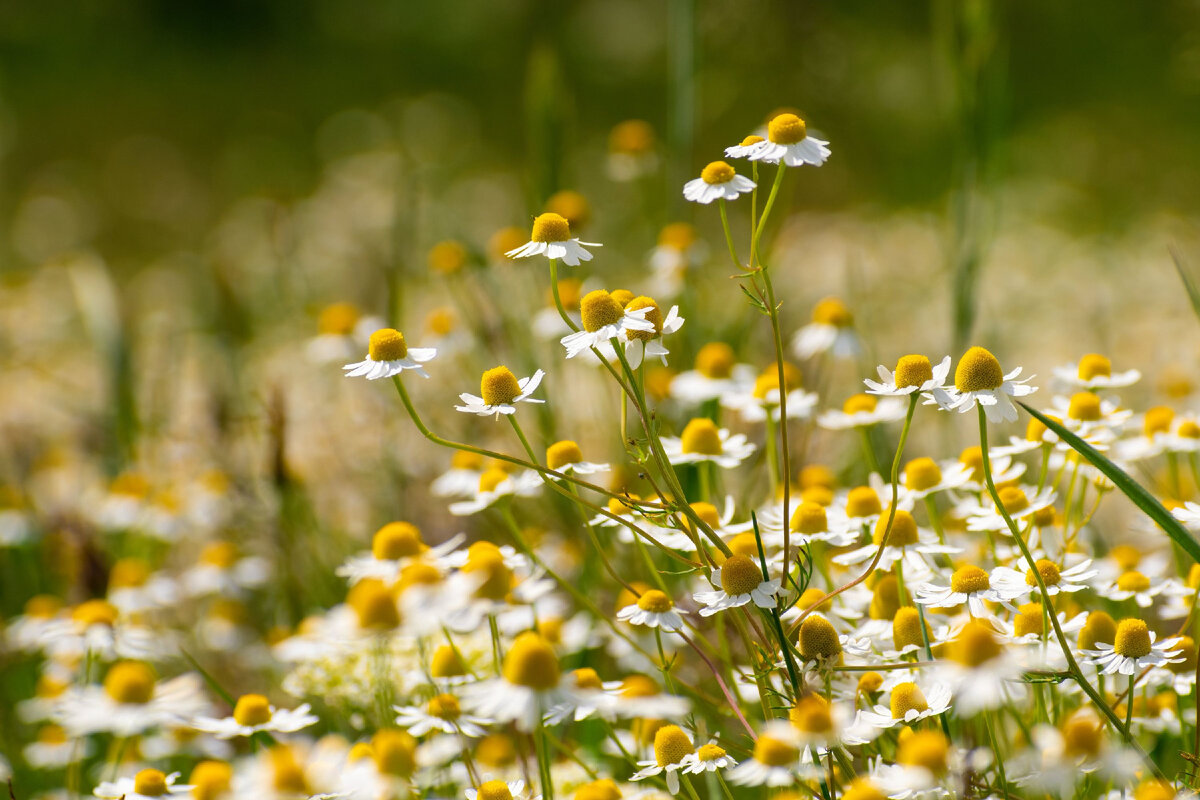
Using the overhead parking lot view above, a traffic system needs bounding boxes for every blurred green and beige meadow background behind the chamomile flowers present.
[0,0,1200,800]
